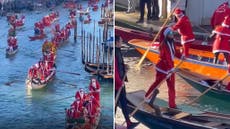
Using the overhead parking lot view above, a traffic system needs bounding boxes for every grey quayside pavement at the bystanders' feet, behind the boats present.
[115,3,212,40]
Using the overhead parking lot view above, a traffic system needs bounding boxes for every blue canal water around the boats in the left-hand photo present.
[0,1,113,129]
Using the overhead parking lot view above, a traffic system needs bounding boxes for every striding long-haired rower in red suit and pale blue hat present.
[145,27,176,108]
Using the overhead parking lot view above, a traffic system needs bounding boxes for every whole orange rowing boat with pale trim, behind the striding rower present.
[128,39,230,82]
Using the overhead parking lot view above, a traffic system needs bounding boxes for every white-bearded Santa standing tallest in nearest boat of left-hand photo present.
[89,78,101,102]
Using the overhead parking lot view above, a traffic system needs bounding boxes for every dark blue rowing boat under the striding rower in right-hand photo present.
[124,90,230,129]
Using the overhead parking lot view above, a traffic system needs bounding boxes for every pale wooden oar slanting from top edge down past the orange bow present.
[136,0,180,70]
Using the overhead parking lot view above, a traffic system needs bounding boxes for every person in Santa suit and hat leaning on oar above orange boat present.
[171,8,195,57]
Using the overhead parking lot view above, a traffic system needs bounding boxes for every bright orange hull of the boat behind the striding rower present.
[129,39,230,81]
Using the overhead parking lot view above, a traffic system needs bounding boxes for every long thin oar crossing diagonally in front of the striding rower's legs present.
[122,60,184,125]
